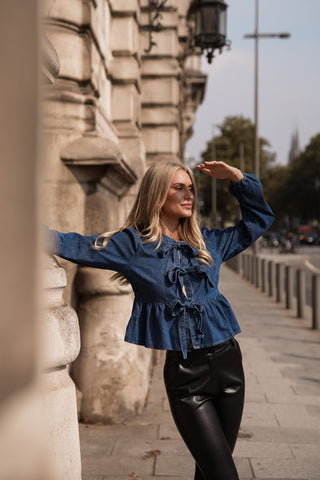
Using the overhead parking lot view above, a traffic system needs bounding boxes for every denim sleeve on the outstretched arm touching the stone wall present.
[46,229,138,275]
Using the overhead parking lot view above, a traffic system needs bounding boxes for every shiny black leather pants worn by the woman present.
[164,339,244,480]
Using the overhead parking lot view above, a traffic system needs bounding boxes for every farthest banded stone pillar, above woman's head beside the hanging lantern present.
[141,0,206,163]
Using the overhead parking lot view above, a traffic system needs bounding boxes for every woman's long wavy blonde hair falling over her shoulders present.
[93,162,212,278]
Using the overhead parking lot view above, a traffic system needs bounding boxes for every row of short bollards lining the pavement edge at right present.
[228,252,320,330]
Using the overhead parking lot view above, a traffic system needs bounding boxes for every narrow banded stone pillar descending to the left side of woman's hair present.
[109,0,146,197]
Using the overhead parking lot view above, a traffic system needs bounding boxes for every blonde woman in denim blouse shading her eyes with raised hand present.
[45,162,274,480]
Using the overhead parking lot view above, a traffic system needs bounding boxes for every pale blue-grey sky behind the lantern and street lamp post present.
[186,0,320,168]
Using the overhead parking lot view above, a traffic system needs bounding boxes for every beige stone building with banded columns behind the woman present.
[43,0,206,432]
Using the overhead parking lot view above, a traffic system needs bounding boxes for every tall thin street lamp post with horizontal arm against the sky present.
[244,0,290,178]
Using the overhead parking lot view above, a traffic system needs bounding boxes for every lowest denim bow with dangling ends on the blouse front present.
[170,300,204,358]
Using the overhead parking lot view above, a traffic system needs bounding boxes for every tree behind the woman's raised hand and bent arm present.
[195,116,275,226]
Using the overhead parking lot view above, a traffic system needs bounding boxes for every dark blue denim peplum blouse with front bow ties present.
[49,174,274,358]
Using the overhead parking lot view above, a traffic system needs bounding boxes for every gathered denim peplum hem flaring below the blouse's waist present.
[124,293,241,357]
